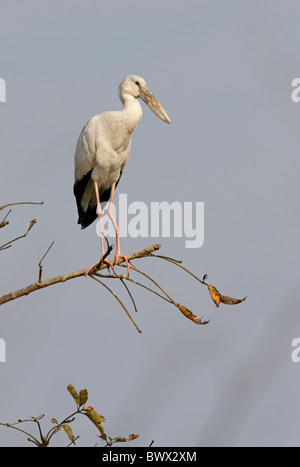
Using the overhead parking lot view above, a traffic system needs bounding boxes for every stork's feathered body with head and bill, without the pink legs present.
[74,75,170,231]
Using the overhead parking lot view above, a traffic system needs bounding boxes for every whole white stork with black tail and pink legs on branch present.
[73,75,171,275]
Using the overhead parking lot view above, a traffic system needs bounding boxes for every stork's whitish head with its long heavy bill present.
[119,75,171,123]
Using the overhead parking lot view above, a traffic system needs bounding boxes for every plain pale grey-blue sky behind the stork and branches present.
[0,0,300,446]
